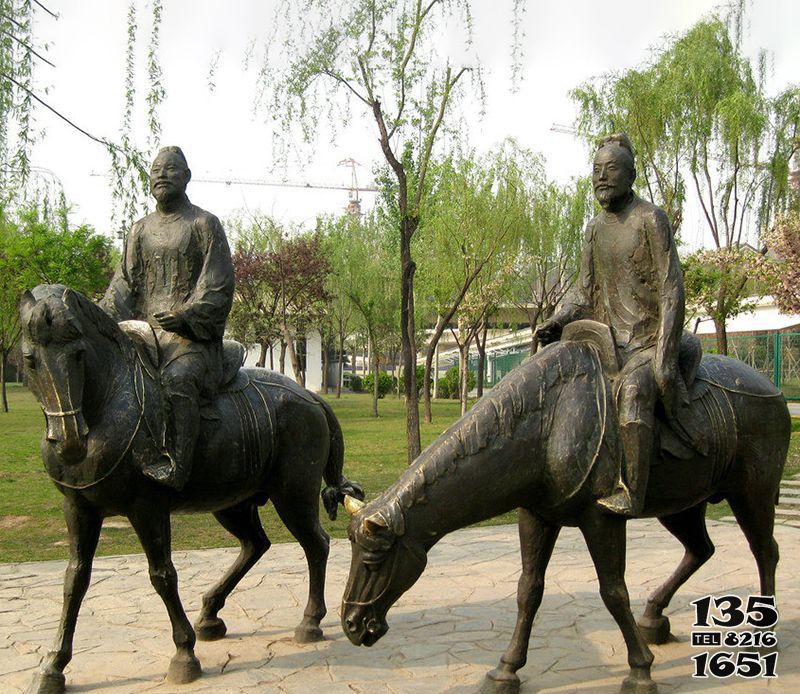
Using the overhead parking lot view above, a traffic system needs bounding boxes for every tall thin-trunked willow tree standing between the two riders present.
[247,0,523,461]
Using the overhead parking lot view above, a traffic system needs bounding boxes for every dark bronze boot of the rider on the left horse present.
[144,393,200,491]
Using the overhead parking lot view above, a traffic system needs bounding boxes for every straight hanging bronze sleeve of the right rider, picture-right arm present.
[646,209,686,378]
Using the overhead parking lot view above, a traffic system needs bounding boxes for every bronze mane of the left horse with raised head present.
[30,284,135,361]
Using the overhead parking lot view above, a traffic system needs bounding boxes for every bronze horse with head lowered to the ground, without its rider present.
[342,321,791,694]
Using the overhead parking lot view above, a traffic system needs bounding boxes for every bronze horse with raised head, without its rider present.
[20,285,363,694]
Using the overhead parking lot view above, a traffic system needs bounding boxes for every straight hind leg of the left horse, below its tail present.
[270,490,330,643]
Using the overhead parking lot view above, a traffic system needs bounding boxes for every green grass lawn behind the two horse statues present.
[0,385,800,562]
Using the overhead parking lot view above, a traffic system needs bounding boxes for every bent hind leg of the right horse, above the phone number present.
[638,502,714,643]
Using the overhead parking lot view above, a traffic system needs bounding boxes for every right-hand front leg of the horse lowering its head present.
[580,507,656,694]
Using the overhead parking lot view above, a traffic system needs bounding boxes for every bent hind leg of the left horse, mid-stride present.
[194,501,270,641]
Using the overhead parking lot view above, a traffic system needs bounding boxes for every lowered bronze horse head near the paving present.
[342,501,427,646]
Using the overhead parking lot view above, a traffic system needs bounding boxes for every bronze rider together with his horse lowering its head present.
[342,135,791,694]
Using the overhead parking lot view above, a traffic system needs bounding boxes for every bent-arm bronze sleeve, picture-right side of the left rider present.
[181,214,234,342]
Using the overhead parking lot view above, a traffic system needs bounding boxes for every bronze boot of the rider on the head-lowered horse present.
[597,422,653,516]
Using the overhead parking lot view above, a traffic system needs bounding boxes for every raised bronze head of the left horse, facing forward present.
[20,285,126,464]
